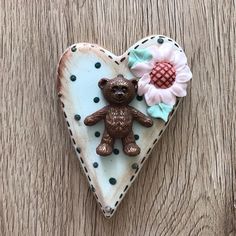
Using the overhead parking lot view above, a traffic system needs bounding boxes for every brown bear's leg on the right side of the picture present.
[122,131,140,156]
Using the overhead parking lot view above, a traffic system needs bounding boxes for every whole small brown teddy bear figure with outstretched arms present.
[84,75,153,156]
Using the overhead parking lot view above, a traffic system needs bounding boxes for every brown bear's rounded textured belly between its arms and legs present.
[105,108,132,138]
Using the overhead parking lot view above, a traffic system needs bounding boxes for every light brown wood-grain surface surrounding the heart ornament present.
[0,0,236,236]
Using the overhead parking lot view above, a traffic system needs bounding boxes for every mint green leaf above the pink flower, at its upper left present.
[128,49,152,68]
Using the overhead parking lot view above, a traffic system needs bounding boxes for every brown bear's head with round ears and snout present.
[98,75,138,105]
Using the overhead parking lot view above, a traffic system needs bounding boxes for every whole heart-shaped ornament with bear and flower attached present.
[57,35,192,217]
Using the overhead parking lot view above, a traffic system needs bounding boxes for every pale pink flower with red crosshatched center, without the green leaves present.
[130,42,192,106]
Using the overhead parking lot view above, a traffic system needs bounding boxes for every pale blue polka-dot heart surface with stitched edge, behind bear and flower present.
[57,35,182,217]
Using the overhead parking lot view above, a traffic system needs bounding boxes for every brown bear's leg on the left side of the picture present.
[96,129,114,156]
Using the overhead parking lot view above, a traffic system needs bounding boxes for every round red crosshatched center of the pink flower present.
[149,62,176,89]
